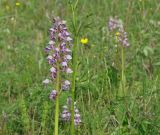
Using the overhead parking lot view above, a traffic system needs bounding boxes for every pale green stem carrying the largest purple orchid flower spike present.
[54,64,60,135]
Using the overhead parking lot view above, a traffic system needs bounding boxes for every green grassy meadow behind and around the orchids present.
[0,0,160,135]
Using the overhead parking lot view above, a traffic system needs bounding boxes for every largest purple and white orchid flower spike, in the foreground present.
[43,17,72,99]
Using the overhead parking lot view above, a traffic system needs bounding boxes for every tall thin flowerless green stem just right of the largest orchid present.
[71,0,78,135]
